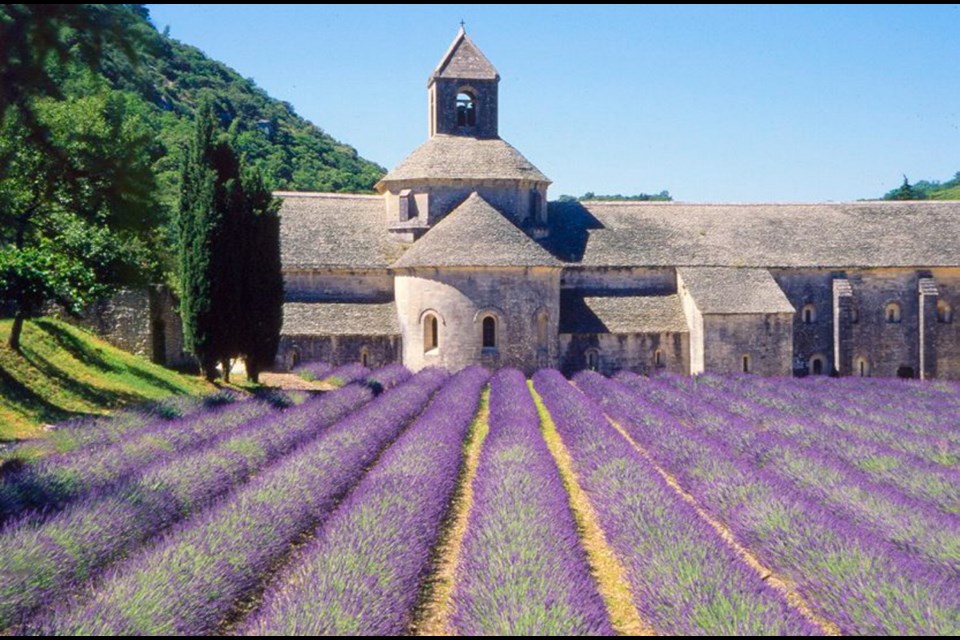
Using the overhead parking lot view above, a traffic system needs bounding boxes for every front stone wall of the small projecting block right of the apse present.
[703,313,793,376]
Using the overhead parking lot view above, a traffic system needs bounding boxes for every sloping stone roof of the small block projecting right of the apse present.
[677,267,795,314]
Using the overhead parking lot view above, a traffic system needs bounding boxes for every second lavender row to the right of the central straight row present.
[576,373,960,634]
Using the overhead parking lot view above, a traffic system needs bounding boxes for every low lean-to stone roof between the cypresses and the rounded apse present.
[280,302,400,336]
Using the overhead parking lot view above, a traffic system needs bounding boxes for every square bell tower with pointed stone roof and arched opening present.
[427,24,500,138]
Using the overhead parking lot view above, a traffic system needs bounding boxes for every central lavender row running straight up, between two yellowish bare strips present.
[452,369,613,635]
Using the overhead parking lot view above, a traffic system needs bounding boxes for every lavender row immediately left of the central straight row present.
[245,367,489,635]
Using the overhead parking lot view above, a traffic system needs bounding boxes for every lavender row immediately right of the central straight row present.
[534,371,819,636]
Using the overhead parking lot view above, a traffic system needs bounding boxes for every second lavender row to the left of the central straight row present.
[36,369,447,635]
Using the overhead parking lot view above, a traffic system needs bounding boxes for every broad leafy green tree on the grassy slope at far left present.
[0,94,158,351]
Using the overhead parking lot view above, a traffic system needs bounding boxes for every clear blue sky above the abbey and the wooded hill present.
[148,5,960,202]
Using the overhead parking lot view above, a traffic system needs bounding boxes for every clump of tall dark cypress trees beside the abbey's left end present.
[178,103,283,381]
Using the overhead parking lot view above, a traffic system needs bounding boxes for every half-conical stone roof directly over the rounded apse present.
[393,192,561,268]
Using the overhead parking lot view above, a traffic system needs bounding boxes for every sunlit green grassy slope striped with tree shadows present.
[0,319,212,442]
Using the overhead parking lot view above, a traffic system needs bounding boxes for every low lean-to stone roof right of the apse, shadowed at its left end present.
[560,291,689,334]
